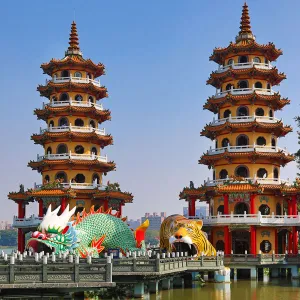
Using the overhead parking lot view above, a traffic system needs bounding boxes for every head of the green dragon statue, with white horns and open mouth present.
[27,205,78,253]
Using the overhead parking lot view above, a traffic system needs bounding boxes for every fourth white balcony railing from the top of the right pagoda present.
[207,144,291,155]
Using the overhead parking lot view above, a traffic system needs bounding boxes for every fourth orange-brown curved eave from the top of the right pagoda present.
[200,121,293,139]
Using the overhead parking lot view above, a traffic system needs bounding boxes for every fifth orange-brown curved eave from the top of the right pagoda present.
[198,151,295,167]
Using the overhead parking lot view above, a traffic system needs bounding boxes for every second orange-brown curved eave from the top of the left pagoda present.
[37,81,108,100]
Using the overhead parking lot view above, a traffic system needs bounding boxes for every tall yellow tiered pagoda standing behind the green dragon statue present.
[8,22,133,252]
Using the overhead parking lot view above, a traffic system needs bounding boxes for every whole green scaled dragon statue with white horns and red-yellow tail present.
[27,205,149,257]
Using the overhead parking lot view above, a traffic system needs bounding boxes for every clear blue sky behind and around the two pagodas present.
[0,0,300,220]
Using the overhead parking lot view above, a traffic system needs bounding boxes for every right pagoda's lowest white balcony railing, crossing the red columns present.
[188,212,300,226]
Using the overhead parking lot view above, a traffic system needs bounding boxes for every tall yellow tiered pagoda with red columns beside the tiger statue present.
[179,3,300,255]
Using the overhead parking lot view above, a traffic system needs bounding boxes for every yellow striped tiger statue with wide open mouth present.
[160,215,217,257]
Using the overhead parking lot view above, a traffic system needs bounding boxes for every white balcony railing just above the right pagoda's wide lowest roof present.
[204,176,291,186]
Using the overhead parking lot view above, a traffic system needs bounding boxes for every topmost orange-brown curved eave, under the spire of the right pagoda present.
[209,41,282,64]
